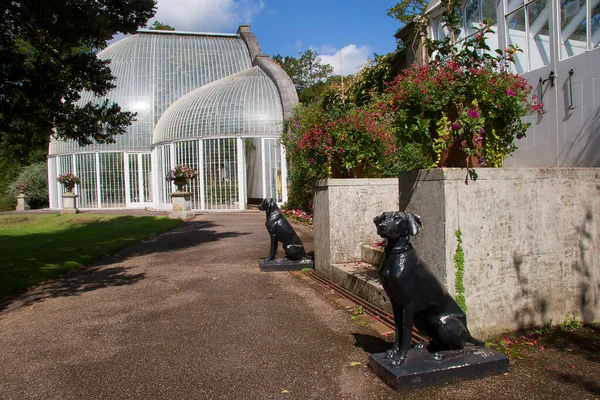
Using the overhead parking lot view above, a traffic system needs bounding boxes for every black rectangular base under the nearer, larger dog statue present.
[369,346,508,391]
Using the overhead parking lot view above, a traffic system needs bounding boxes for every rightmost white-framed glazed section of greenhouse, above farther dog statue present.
[261,138,287,204]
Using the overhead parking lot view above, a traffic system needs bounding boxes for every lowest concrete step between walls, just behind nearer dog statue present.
[331,261,392,314]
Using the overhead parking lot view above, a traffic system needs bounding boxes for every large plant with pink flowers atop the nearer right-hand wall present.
[378,0,542,168]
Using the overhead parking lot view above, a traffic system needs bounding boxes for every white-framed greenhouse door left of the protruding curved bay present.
[125,153,152,208]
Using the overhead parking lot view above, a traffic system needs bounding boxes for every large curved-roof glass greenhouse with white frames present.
[48,26,298,210]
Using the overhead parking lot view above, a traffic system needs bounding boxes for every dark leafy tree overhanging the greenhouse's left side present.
[0,0,155,164]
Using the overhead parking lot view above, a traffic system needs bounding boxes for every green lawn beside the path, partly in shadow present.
[0,214,181,296]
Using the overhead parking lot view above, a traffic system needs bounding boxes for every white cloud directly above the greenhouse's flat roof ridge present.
[150,0,264,32]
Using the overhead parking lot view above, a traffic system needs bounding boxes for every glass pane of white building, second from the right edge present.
[560,0,587,59]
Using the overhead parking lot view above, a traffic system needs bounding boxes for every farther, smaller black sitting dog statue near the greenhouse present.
[258,197,306,261]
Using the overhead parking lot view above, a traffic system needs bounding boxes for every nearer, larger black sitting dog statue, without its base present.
[373,211,485,366]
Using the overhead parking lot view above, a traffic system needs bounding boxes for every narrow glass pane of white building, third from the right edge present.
[527,0,550,71]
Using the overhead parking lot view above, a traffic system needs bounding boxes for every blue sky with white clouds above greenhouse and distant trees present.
[143,0,399,75]
